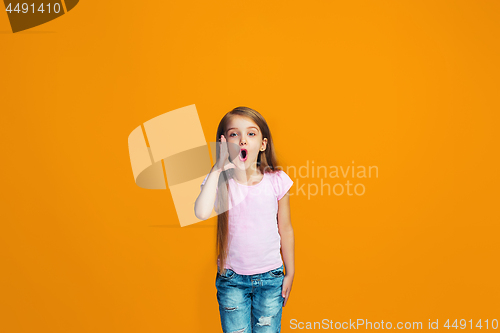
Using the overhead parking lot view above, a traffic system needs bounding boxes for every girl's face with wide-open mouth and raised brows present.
[224,116,267,170]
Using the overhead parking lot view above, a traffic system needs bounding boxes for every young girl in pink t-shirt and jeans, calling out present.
[195,107,295,333]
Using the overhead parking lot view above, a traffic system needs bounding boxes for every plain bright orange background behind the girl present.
[0,0,500,332]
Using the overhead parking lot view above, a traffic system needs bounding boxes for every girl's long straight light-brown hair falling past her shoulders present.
[216,106,278,274]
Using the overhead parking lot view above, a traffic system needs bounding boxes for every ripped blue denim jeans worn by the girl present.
[215,265,285,333]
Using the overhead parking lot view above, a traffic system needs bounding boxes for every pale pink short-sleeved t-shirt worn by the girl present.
[201,170,293,275]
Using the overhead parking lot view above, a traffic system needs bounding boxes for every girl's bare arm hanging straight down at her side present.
[278,192,295,306]
